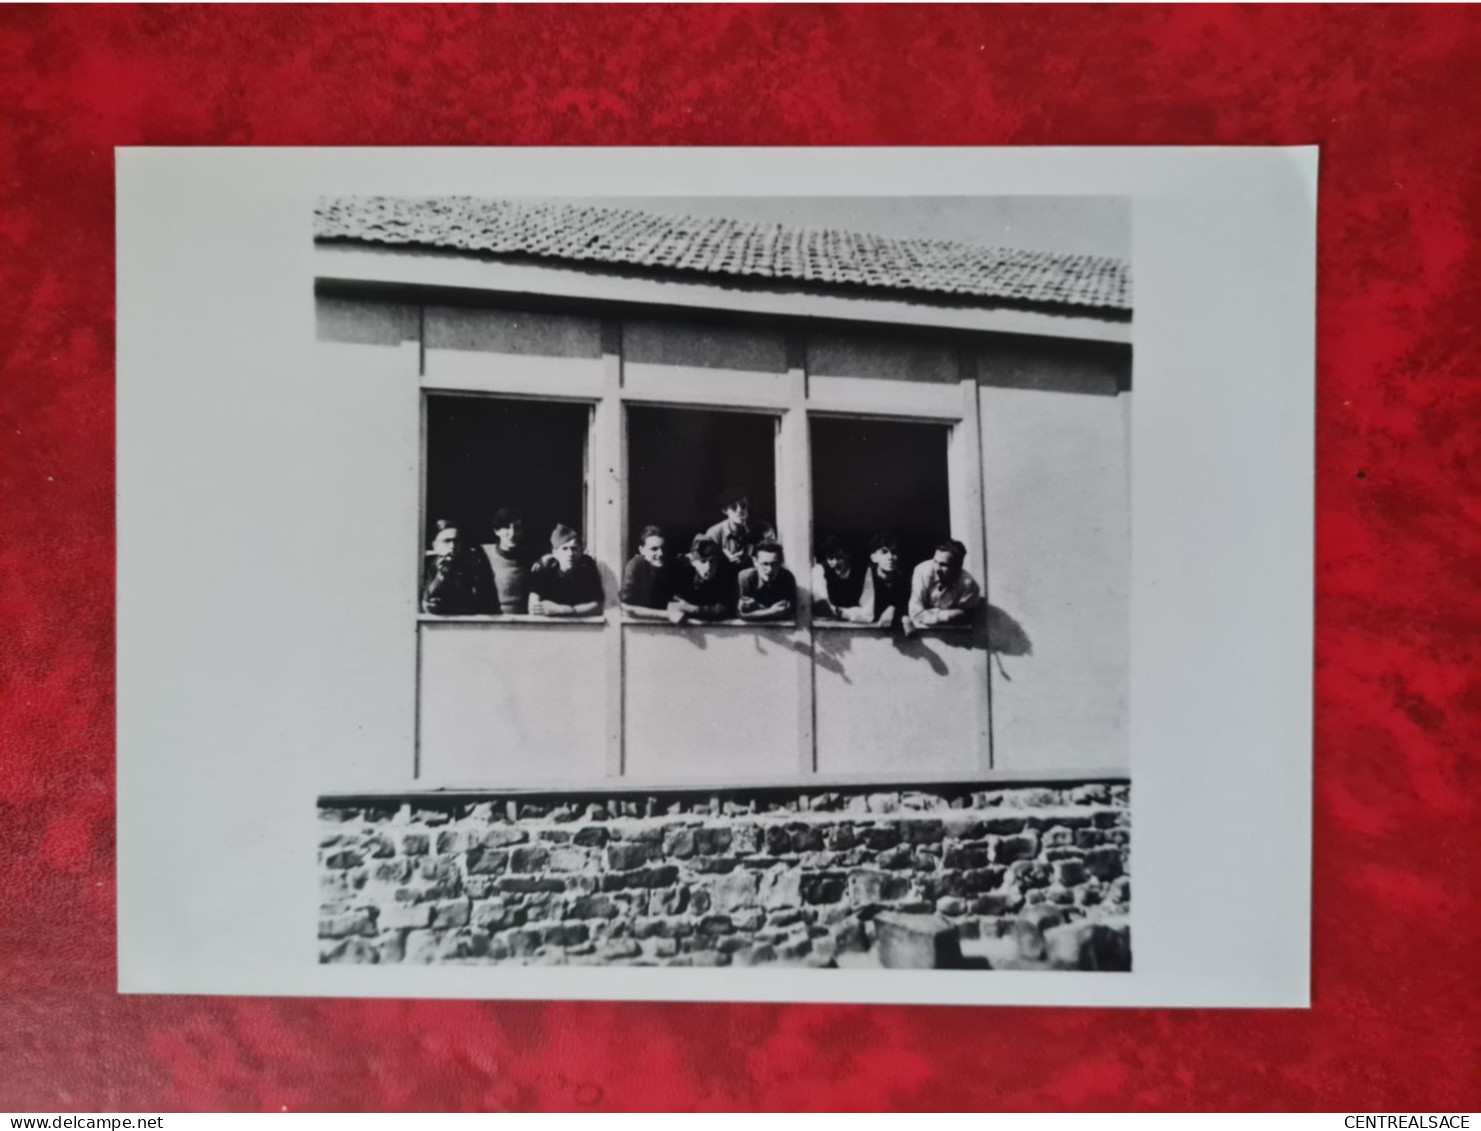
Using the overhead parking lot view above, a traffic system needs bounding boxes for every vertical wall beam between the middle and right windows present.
[776,339,818,774]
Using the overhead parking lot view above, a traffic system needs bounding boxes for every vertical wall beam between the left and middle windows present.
[591,321,628,777]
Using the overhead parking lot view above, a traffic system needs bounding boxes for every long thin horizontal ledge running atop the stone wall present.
[318,767,1131,817]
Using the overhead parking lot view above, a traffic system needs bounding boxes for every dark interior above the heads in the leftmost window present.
[422,395,591,560]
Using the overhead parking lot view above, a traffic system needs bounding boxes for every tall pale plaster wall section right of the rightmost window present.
[979,373,1130,770]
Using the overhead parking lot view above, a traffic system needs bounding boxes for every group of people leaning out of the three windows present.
[422,487,982,635]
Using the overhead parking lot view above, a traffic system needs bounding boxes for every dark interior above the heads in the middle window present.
[626,407,776,558]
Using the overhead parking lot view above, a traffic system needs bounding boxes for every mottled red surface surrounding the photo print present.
[0,6,1481,1112]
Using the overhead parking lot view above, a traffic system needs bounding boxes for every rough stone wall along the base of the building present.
[318,783,1130,968]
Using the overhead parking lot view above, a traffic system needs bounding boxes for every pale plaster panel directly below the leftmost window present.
[421,622,616,786]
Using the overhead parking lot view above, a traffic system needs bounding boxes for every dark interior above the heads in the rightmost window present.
[812,416,951,568]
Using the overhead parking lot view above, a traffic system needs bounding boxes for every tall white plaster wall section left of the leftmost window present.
[308,298,421,785]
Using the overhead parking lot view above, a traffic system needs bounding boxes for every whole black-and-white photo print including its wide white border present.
[117,150,1315,1007]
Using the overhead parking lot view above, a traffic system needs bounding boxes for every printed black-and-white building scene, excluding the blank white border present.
[314,195,1134,971]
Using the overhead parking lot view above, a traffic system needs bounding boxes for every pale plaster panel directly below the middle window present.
[624,625,806,785]
